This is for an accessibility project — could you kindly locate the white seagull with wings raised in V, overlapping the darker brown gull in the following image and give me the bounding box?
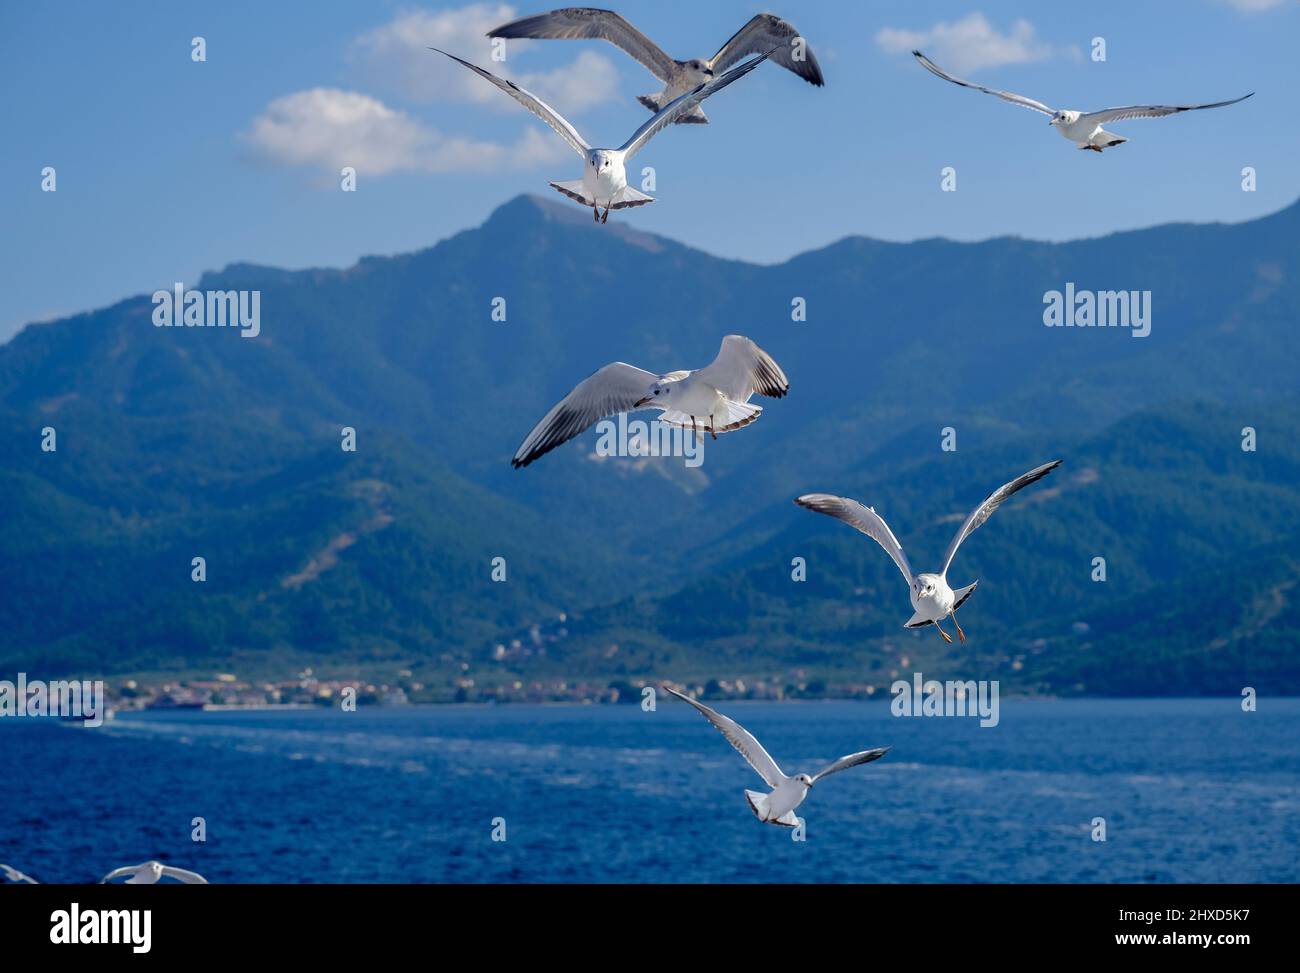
[429,47,772,222]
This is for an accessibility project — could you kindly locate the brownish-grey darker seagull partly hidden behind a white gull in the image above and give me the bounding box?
[488,7,826,125]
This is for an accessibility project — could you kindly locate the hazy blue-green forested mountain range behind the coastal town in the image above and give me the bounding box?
[0,196,1300,695]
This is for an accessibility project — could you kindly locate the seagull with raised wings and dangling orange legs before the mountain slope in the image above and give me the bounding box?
[794,459,1061,643]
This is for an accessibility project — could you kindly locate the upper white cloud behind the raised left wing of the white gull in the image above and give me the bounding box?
[348,4,619,116]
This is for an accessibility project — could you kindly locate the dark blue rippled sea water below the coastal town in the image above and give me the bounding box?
[0,699,1300,882]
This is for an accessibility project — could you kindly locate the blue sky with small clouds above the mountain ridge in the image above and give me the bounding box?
[0,0,1300,340]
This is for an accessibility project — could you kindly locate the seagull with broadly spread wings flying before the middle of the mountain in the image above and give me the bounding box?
[511,334,790,470]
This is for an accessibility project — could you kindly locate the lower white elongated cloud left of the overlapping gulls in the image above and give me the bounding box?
[244,88,568,178]
